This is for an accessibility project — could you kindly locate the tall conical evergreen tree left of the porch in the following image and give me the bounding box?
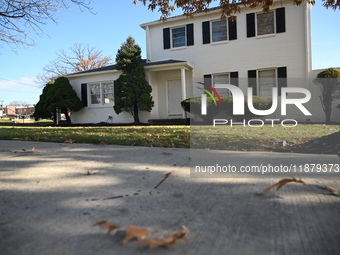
[113,37,154,125]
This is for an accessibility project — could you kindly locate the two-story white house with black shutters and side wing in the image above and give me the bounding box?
[66,1,340,123]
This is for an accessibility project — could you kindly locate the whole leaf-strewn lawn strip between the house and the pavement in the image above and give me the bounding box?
[0,119,340,151]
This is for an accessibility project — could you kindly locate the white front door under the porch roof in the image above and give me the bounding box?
[168,79,183,117]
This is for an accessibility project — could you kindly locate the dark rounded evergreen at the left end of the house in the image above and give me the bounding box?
[33,77,83,124]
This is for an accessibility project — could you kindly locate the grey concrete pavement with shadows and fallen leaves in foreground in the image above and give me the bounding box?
[0,141,340,255]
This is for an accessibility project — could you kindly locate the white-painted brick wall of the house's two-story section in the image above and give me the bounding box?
[142,2,319,121]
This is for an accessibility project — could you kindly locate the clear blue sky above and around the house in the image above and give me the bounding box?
[0,0,340,105]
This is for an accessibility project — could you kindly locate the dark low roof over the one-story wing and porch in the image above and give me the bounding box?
[65,59,191,78]
